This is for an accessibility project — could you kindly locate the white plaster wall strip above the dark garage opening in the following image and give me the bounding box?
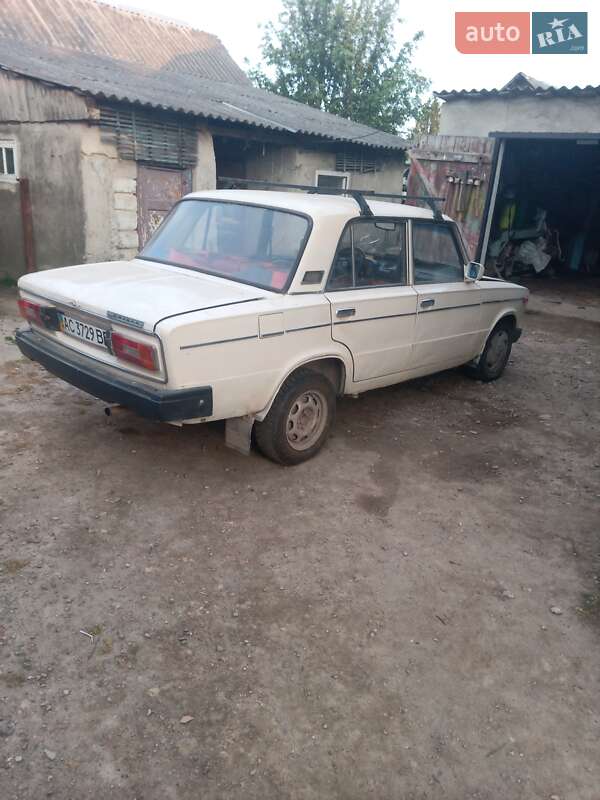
[440,97,600,136]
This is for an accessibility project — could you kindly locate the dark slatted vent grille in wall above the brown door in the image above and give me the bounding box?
[100,107,196,169]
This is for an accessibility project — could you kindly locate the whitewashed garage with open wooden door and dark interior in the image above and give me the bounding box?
[409,73,600,290]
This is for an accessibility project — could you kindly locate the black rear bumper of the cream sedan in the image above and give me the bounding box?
[16,330,213,422]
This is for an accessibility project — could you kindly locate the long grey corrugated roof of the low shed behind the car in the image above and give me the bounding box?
[0,34,408,150]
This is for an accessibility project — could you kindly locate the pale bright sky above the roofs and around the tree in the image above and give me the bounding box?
[110,0,600,91]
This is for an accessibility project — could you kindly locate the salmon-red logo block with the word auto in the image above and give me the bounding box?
[454,11,531,55]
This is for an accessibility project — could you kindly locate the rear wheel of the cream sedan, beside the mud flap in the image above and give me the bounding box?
[254,369,335,466]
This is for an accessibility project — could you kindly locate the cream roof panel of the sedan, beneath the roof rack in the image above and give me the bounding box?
[184,189,440,219]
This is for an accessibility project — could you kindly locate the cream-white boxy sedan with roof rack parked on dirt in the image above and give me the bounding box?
[17,189,528,465]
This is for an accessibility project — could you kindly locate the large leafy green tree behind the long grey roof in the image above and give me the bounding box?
[250,0,429,133]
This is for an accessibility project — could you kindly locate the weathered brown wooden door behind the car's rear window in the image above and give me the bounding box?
[137,164,192,249]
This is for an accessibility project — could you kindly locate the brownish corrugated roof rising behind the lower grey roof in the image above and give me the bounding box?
[0,0,250,84]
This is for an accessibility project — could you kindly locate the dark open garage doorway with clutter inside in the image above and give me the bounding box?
[485,137,600,280]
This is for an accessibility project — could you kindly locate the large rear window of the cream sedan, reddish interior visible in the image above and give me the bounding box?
[140,200,309,291]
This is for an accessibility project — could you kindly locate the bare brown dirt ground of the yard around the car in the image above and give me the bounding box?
[0,292,600,800]
